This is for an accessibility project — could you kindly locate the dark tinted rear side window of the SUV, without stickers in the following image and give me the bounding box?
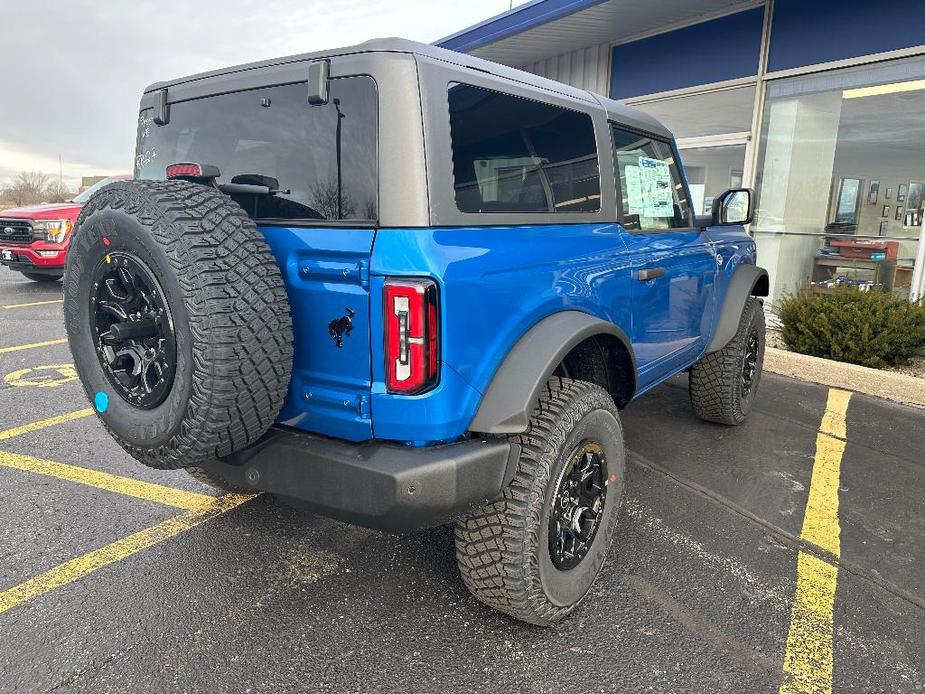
[449,84,601,213]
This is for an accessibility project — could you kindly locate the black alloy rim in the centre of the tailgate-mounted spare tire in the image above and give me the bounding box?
[90,251,177,409]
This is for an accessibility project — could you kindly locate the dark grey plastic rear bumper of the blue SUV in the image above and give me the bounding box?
[204,426,520,532]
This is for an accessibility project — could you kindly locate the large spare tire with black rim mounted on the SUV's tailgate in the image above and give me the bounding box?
[64,181,292,469]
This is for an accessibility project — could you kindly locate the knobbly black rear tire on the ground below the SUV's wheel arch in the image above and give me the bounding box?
[456,377,626,626]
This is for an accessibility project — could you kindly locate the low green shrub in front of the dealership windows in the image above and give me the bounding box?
[779,288,925,368]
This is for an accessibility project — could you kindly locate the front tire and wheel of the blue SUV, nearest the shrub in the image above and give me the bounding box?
[688,297,765,426]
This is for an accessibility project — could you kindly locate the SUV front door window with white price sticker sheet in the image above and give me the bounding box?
[613,126,691,231]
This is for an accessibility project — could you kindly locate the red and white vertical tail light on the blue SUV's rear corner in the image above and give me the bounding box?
[383,279,440,395]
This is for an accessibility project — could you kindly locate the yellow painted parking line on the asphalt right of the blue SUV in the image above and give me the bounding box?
[780,388,851,694]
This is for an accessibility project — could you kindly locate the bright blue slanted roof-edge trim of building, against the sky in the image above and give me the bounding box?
[435,0,607,53]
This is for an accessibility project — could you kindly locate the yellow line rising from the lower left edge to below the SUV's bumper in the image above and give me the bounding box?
[0,494,254,613]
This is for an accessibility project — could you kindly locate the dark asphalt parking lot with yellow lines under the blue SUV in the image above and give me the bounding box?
[0,268,925,693]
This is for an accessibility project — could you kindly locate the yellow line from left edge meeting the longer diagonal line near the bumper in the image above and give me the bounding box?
[0,451,215,511]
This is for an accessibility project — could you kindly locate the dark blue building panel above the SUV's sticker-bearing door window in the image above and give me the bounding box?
[610,7,764,99]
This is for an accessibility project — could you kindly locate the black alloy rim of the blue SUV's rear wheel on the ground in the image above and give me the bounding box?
[549,441,607,571]
